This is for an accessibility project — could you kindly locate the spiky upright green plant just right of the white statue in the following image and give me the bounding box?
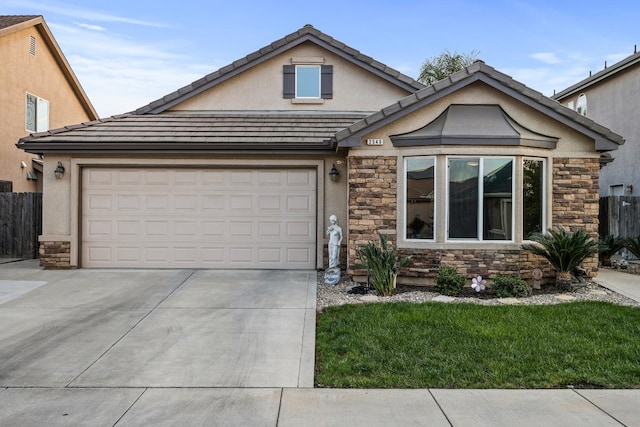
[356,233,411,296]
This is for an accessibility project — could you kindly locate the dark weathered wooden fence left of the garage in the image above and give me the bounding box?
[0,193,42,259]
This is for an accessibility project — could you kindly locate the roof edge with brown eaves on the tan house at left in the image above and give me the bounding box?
[0,15,98,119]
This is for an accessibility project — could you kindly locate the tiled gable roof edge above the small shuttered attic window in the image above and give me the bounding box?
[135,24,425,114]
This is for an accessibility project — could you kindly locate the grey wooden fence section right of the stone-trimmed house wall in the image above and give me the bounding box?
[599,196,640,237]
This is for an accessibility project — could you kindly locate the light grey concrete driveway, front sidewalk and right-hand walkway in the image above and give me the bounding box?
[0,261,640,427]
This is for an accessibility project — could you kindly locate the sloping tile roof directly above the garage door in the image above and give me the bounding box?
[18,112,370,153]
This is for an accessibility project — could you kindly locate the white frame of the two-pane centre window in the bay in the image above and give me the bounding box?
[445,155,517,245]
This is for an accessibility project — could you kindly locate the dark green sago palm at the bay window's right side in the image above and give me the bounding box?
[522,227,598,291]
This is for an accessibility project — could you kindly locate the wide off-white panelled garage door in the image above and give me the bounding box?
[80,168,316,269]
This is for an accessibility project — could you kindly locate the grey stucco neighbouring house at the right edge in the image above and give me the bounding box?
[553,52,640,197]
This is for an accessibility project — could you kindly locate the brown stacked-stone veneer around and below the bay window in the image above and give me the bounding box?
[348,157,599,280]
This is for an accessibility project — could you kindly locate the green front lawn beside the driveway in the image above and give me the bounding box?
[315,302,640,388]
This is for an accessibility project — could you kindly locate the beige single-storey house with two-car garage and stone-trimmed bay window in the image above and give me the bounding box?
[19,26,622,281]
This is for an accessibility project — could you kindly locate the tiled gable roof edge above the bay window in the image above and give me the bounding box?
[336,61,624,151]
